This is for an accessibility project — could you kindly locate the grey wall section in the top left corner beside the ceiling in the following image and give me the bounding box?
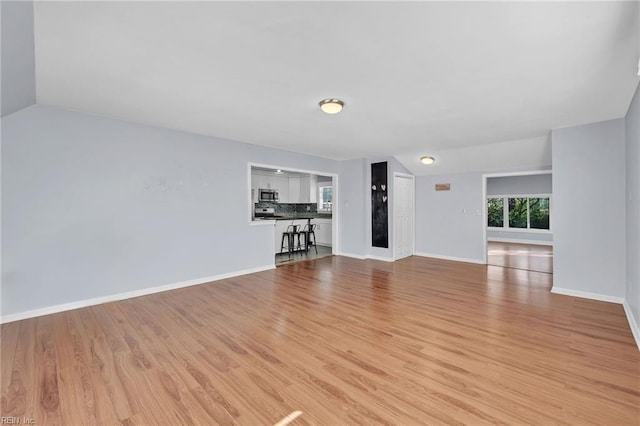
[0,1,36,117]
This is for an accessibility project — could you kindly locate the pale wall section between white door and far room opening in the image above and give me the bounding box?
[416,173,486,263]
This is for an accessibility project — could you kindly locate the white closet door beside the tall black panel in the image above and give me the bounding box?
[393,175,415,259]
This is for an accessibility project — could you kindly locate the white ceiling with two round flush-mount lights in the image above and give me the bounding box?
[34,1,639,174]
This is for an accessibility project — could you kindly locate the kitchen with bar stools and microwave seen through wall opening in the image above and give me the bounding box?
[251,166,333,265]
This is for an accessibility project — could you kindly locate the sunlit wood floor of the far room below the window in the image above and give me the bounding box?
[487,241,553,274]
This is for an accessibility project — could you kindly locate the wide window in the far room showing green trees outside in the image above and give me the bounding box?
[487,195,551,231]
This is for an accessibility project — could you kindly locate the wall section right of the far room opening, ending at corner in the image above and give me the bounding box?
[552,119,626,298]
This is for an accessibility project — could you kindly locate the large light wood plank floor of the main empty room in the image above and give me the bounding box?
[1,256,640,425]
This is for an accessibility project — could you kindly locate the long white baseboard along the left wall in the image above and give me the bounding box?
[0,265,275,324]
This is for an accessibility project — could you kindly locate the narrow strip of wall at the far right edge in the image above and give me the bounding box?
[624,83,640,338]
